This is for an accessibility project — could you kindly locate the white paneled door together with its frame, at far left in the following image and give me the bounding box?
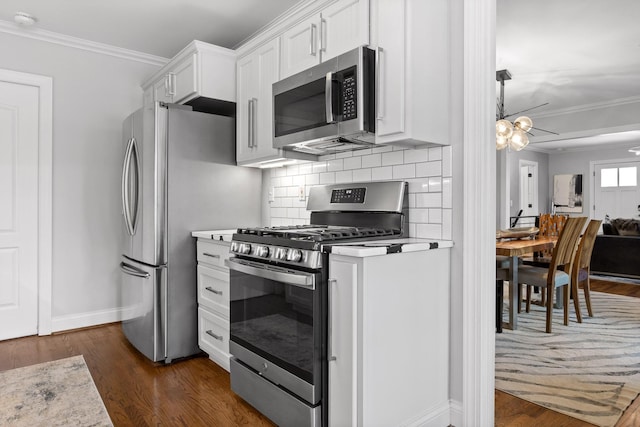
[0,69,53,339]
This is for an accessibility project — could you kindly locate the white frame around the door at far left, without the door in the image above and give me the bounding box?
[0,69,53,335]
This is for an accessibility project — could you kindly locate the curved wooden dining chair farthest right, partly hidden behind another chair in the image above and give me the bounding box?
[571,219,602,323]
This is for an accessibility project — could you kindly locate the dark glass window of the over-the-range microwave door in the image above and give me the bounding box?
[273,79,327,137]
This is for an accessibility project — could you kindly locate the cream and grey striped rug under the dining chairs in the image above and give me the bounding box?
[496,291,640,426]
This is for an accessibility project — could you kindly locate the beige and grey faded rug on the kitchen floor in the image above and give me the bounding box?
[0,356,113,427]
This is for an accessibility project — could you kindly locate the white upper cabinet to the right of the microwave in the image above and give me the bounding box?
[371,0,451,145]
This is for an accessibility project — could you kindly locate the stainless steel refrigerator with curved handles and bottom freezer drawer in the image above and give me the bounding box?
[120,103,262,363]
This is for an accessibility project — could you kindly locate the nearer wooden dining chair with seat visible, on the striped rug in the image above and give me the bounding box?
[518,217,587,333]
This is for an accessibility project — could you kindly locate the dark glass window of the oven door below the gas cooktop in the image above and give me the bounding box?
[231,271,322,384]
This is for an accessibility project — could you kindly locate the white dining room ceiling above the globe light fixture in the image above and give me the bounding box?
[496,0,640,149]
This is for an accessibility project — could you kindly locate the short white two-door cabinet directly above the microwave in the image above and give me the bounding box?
[281,0,369,78]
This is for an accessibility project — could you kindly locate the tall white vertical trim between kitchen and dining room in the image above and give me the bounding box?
[461,0,496,426]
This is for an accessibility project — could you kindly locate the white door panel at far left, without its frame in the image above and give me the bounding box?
[0,81,39,340]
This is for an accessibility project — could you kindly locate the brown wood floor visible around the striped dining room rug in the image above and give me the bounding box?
[495,280,640,427]
